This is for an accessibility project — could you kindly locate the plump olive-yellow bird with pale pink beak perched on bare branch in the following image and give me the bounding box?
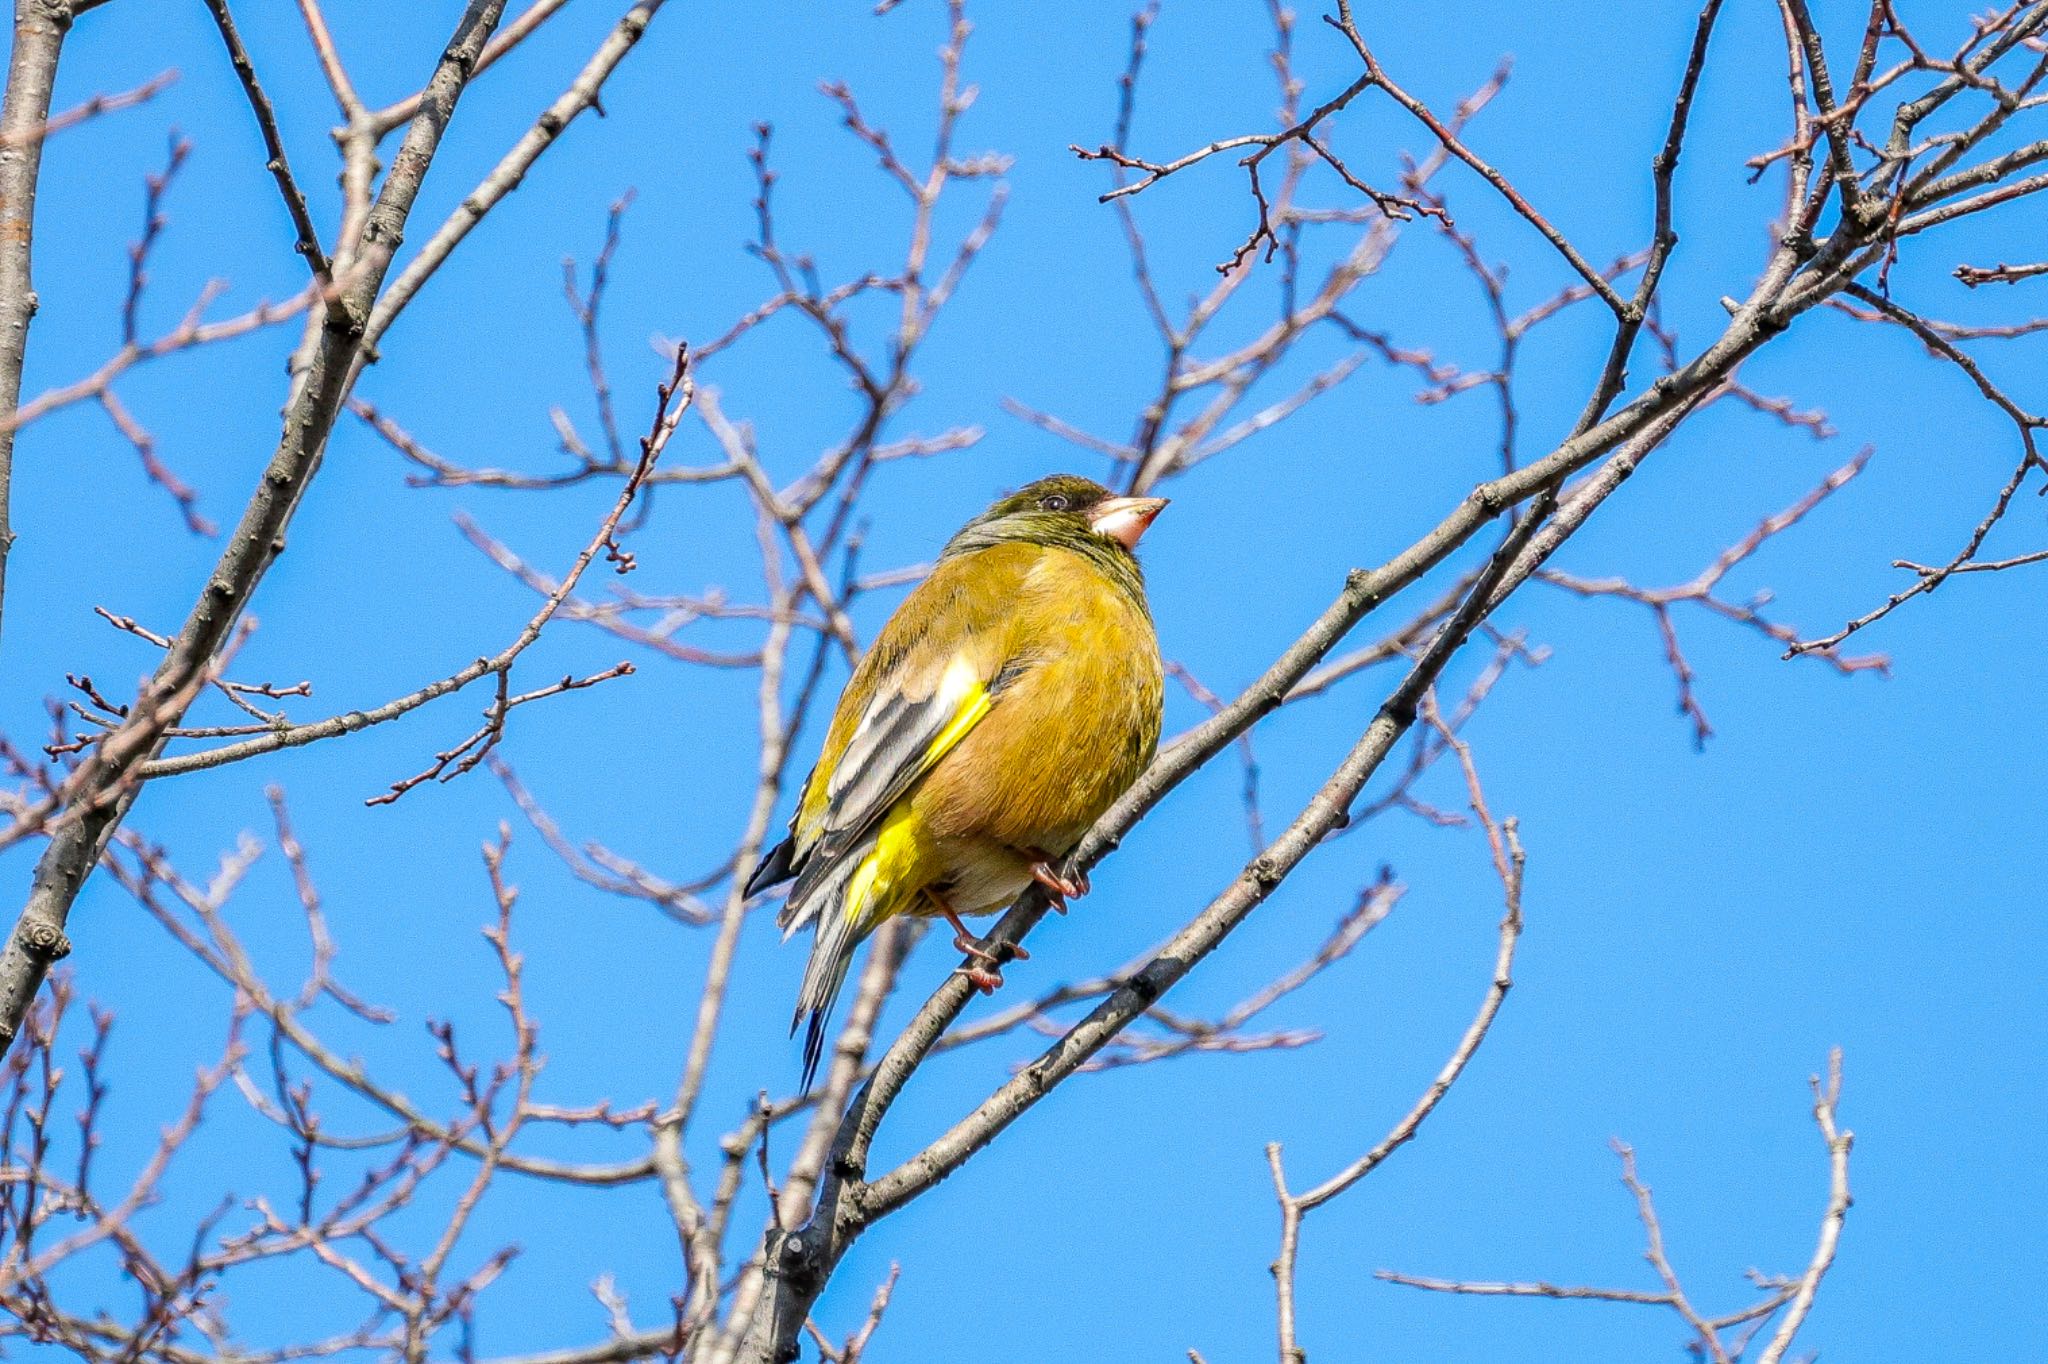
[745,475,1165,1090]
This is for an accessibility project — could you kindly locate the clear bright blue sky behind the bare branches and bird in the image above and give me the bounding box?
[0,0,2048,1364]
